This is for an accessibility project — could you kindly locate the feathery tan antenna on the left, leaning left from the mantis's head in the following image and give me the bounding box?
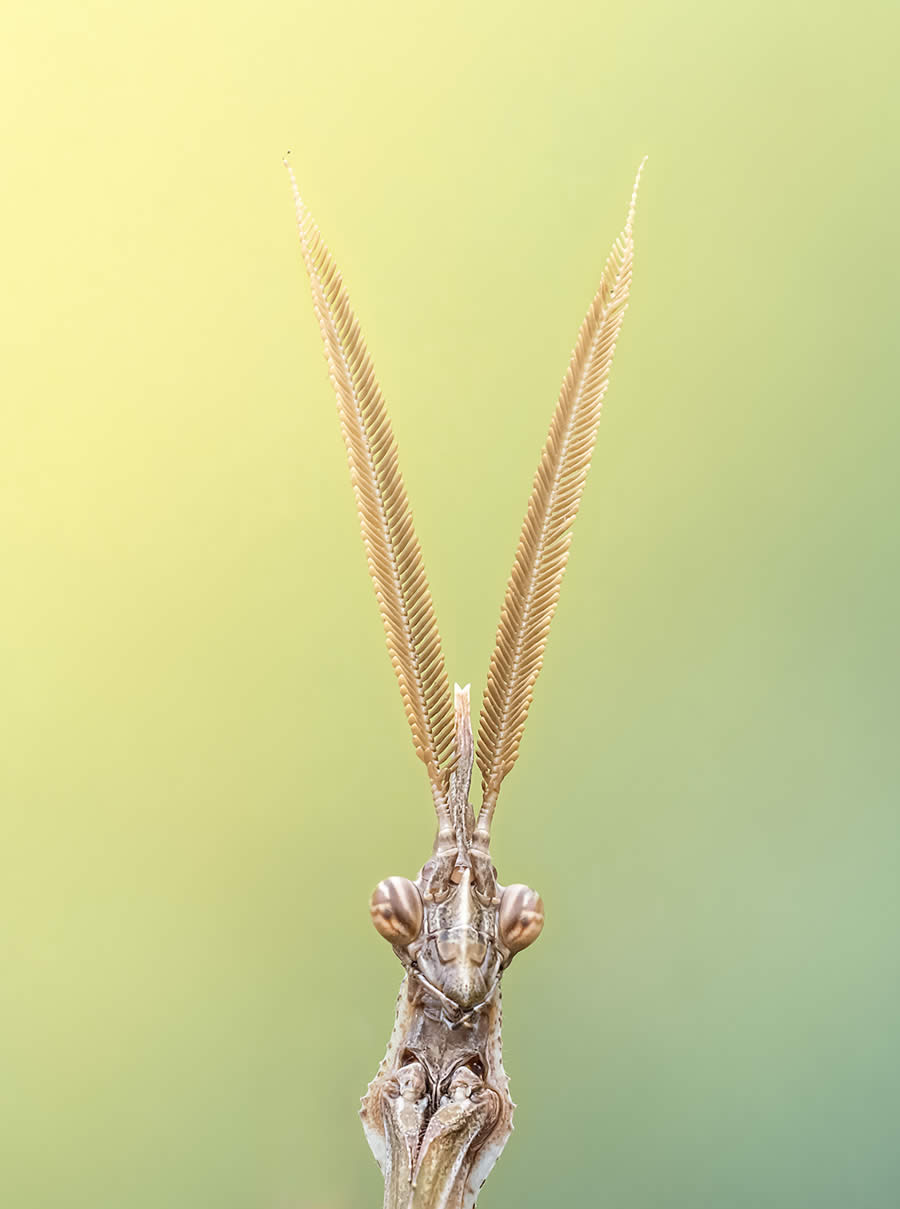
[284,160,455,828]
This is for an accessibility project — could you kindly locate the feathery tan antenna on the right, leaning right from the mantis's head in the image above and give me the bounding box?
[474,158,646,849]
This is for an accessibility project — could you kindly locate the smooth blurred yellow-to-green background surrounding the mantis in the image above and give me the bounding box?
[0,0,900,1209]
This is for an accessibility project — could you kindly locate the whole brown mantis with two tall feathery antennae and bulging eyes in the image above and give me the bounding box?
[285,160,644,1209]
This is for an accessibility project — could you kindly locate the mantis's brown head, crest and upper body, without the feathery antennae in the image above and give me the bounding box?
[362,686,543,1209]
